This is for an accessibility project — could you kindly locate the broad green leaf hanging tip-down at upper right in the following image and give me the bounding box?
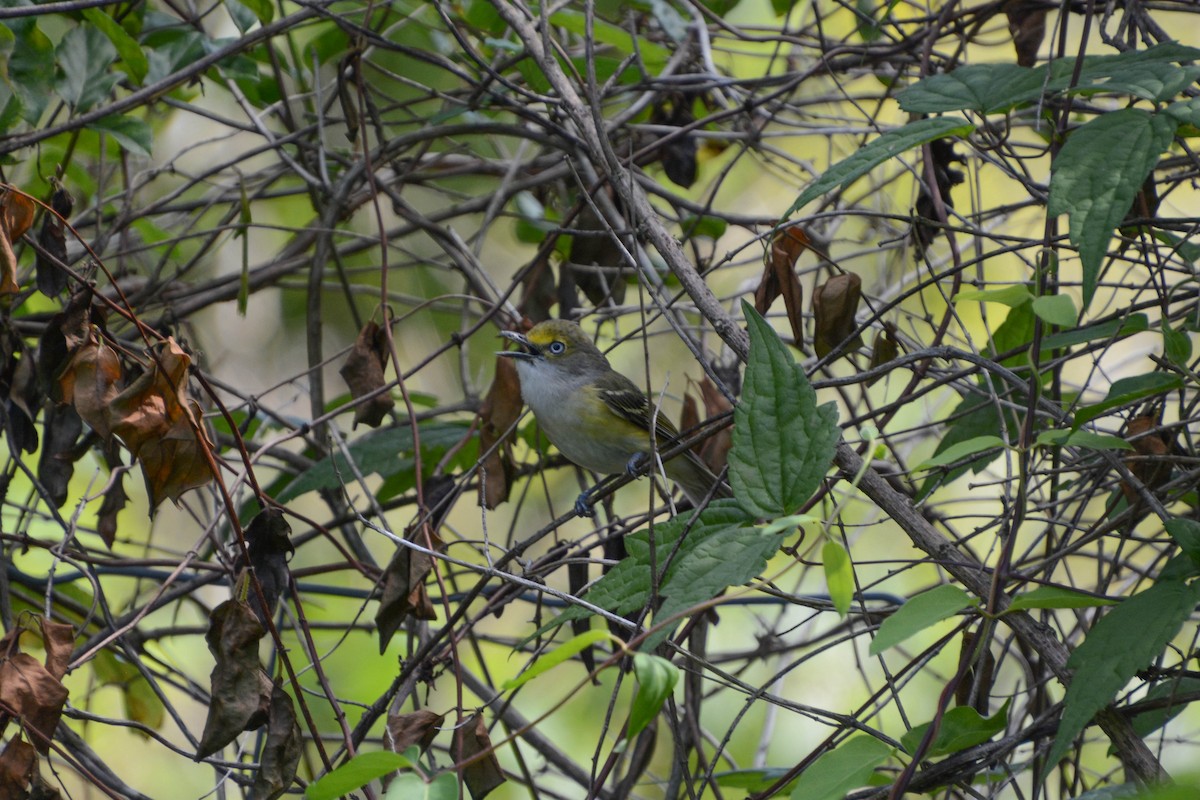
[1046,108,1175,311]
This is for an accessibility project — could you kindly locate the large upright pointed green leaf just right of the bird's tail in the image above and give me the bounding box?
[728,302,841,519]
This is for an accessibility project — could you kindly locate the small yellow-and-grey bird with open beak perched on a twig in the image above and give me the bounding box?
[499,319,730,517]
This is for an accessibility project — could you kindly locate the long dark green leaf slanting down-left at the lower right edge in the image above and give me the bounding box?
[1043,581,1200,778]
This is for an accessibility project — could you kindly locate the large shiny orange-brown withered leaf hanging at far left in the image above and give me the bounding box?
[108,338,212,509]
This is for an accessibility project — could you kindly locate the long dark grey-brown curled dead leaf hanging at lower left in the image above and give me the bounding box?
[196,600,274,760]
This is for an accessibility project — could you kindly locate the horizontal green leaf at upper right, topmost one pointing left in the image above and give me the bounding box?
[896,64,1046,114]
